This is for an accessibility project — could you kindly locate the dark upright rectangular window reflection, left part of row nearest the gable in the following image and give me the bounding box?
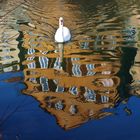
[40,77,49,91]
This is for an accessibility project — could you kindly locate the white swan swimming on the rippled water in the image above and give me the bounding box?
[55,17,71,43]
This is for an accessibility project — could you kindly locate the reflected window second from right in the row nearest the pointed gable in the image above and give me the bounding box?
[84,87,96,101]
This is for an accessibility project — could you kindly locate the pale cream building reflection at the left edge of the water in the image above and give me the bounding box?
[0,26,20,72]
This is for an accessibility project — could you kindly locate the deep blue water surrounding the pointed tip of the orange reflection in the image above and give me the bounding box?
[0,72,140,140]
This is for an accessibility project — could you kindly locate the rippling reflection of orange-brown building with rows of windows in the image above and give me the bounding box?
[23,31,120,129]
